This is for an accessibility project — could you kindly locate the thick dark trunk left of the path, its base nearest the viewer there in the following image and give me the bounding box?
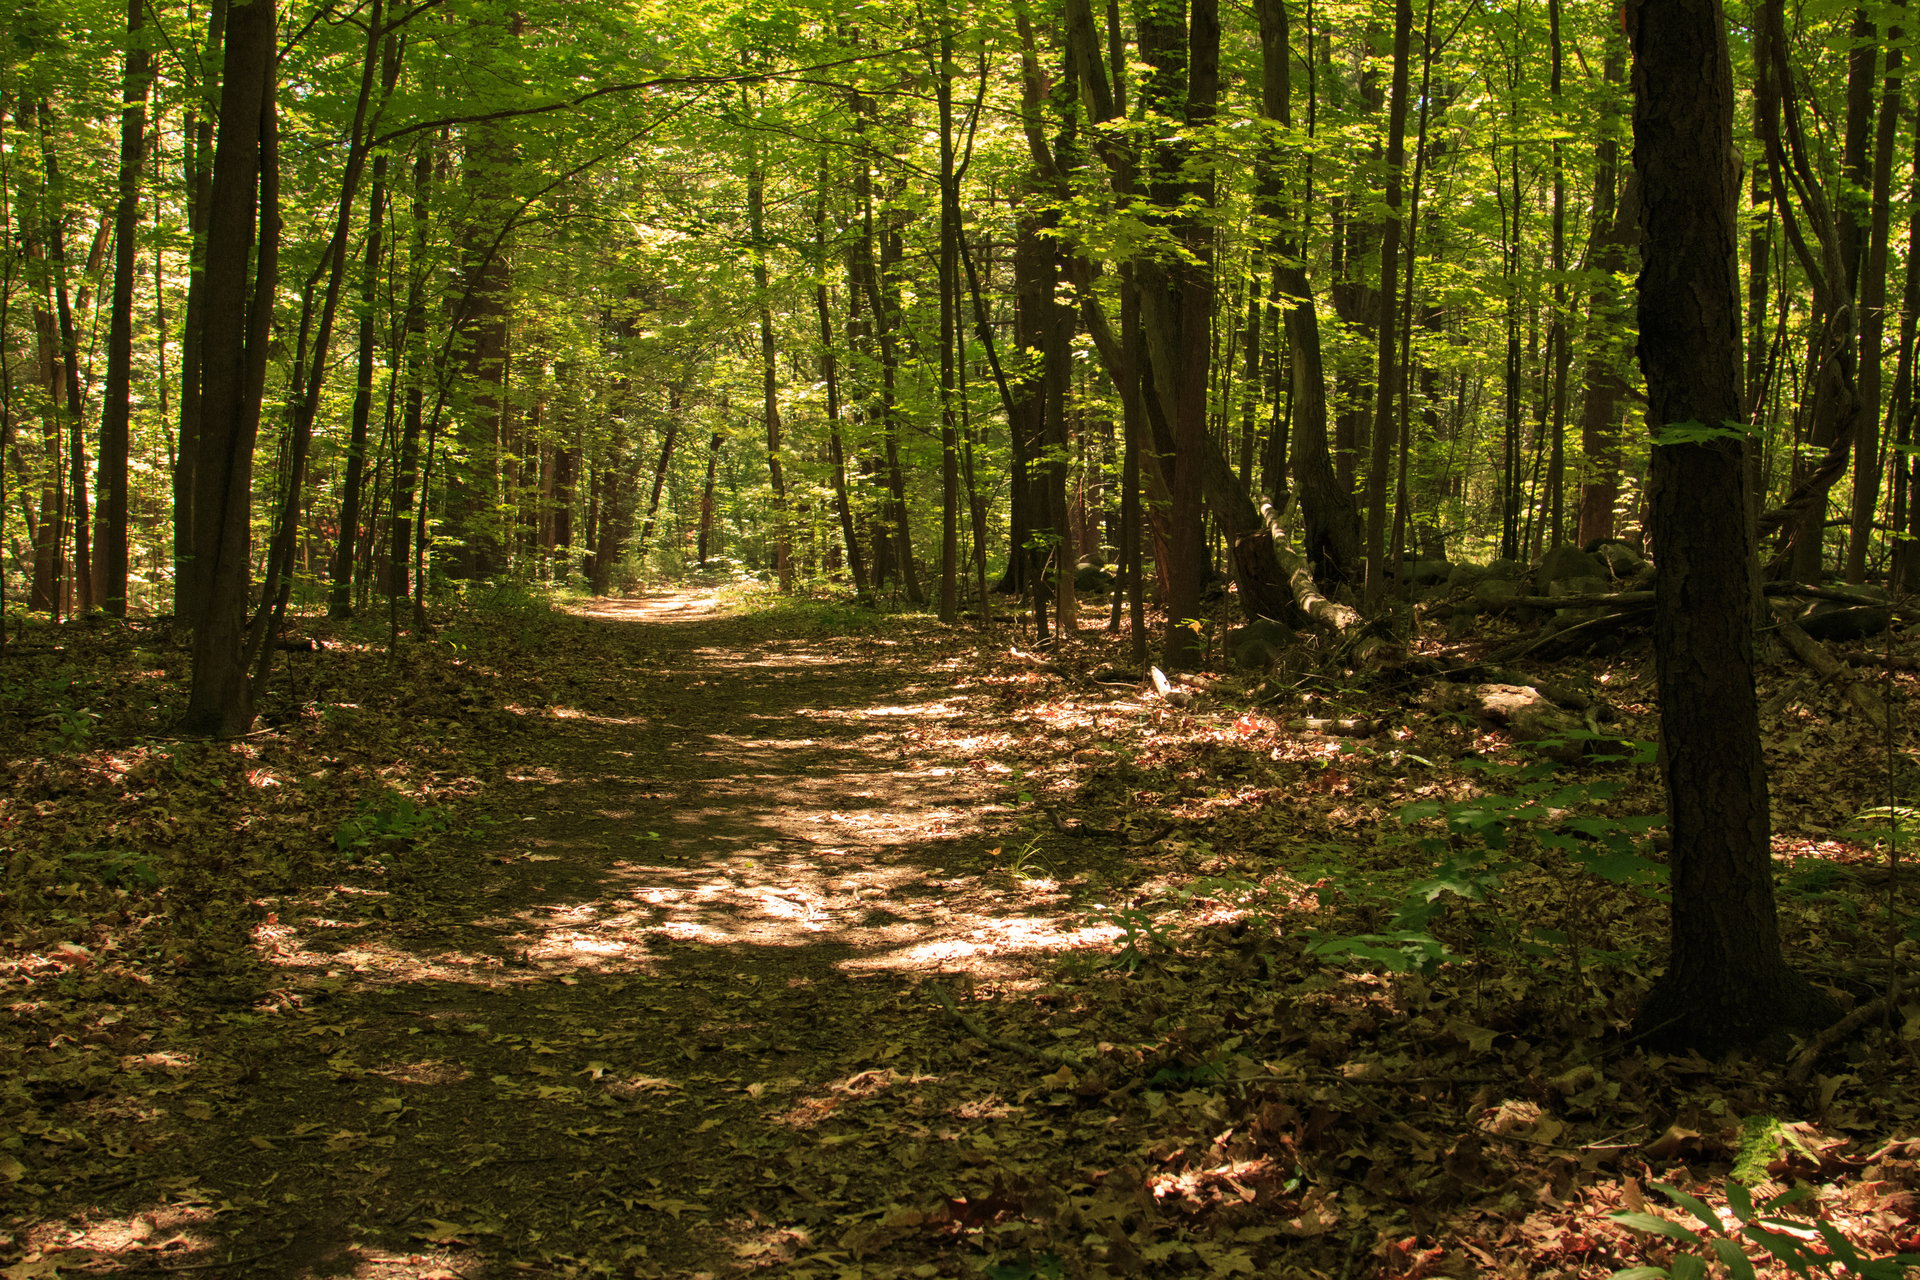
[182,0,280,735]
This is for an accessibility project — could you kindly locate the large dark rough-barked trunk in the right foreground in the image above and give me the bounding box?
[1626,0,1832,1052]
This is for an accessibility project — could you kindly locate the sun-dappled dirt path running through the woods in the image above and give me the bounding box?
[120,595,1105,1278]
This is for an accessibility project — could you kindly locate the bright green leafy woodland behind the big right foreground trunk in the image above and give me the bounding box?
[0,0,1920,714]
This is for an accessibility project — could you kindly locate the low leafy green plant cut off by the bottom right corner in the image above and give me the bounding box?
[1611,1180,1920,1280]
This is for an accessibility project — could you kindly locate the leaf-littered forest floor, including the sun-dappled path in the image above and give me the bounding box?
[0,591,1920,1280]
